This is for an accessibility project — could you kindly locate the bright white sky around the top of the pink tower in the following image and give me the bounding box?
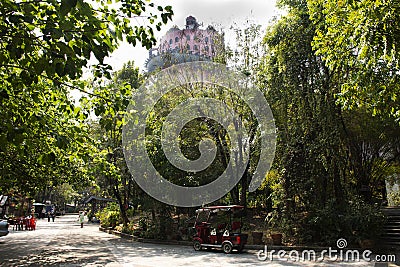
[105,0,282,70]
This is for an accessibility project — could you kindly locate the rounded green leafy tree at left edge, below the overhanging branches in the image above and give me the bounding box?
[0,79,90,196]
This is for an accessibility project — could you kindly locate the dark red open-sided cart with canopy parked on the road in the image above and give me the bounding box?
[193,205,248,254]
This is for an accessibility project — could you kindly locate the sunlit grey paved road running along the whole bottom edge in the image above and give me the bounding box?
[0,215,396,267]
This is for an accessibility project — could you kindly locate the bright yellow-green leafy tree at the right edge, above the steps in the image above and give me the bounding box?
[307,0,400,197]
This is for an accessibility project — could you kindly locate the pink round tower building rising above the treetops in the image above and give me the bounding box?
[146,16,224,72]
